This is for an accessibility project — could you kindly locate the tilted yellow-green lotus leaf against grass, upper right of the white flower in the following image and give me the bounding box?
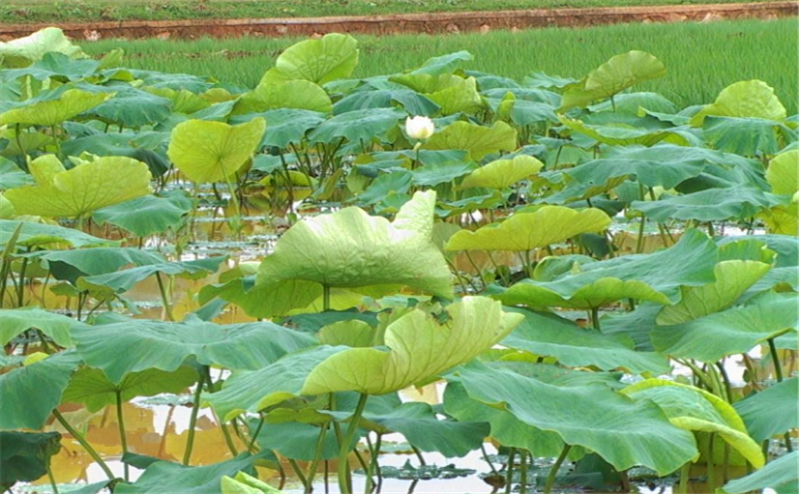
[561,50,667,110]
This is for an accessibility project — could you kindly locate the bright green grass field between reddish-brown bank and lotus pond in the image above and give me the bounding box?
[82,19,798,114]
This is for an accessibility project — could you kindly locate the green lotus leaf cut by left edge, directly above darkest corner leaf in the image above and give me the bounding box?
[0,350,80,430]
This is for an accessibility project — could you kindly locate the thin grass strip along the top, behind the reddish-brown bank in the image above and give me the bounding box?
[0,0,780,23]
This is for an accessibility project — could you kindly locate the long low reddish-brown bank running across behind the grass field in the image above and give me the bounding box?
[0,0,798,39]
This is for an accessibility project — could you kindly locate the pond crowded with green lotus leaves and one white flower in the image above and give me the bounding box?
[0,28,798,494]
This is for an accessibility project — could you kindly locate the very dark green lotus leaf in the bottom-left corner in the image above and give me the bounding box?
[0,431,61,490]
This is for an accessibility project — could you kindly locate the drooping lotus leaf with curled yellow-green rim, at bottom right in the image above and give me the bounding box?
[620,379,765,468]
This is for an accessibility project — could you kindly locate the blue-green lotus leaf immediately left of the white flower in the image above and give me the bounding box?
[308,108,406,144]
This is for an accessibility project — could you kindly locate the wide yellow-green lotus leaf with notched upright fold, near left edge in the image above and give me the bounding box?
[5,155,151,218]
